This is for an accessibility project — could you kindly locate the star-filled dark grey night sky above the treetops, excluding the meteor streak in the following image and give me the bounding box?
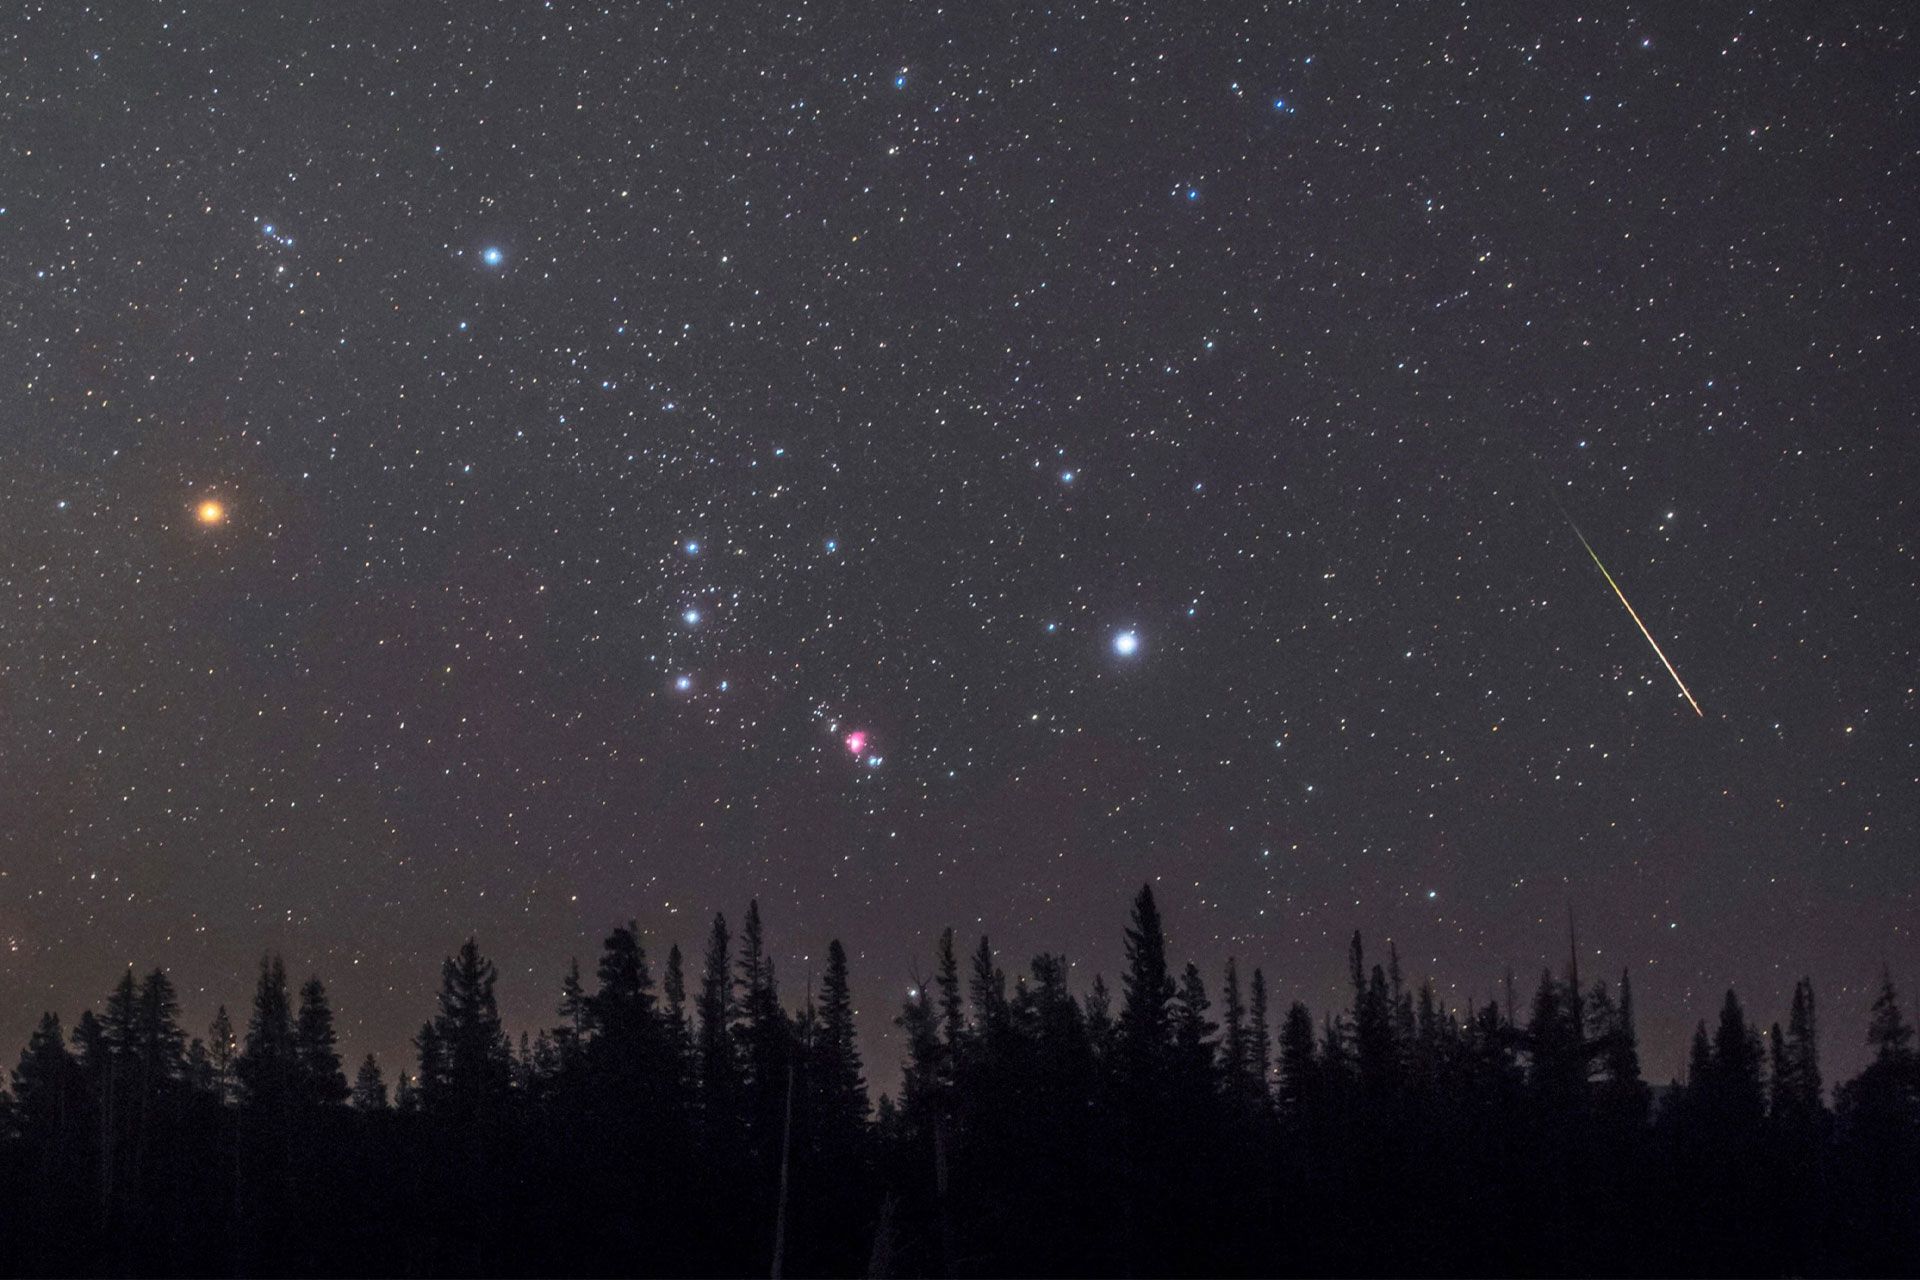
[0,0,1920,1090]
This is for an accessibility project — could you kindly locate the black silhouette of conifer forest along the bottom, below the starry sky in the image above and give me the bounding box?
[0,889,1920,1276]
